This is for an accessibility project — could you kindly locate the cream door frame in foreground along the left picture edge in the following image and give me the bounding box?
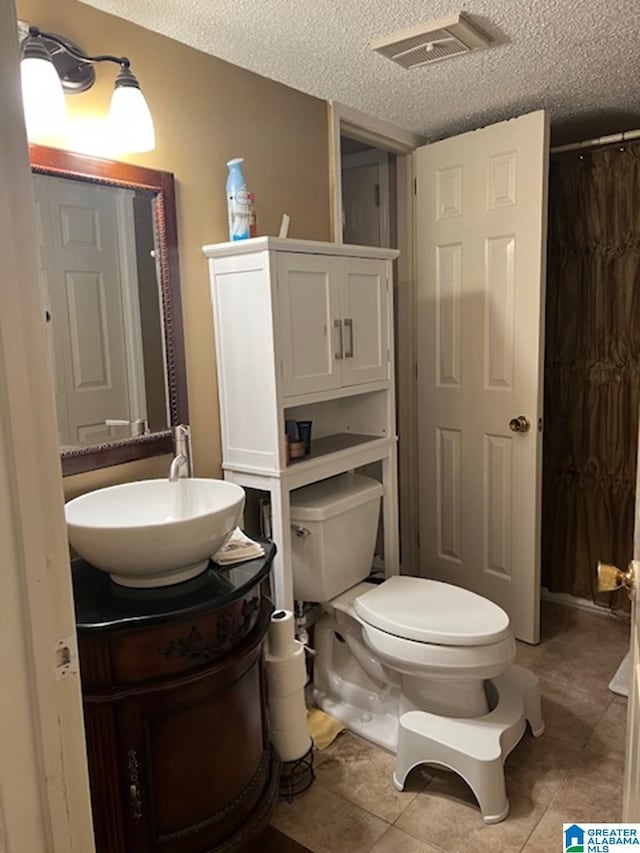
[0,3,94,853]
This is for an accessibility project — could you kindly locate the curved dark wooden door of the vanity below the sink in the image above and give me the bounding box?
[118,650,270,853]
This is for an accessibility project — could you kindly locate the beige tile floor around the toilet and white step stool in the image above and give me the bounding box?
[272,602,629,853]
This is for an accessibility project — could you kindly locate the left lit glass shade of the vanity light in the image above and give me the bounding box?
[20,57,67,142]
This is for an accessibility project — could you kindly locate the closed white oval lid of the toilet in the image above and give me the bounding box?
[354,575,511,646]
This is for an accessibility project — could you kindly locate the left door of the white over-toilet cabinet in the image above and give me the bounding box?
[277,252,344,397]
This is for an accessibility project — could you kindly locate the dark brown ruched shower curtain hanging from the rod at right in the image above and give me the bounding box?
[542,143,640,598]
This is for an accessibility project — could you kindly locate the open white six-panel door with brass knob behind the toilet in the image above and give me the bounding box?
[416,112,548,643]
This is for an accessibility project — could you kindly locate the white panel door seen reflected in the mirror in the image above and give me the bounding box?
[34,175,137,445]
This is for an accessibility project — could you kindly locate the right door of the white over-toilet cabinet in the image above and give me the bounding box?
[339,258,389,385]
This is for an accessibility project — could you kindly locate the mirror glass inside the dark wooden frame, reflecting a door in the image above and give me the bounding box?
[33,174,170,449]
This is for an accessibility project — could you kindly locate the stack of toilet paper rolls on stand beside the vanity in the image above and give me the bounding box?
[265,610,311,761]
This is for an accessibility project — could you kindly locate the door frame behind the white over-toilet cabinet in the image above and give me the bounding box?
[329,101,425,575]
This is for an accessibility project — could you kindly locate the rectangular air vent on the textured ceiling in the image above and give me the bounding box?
[371,12,491,69]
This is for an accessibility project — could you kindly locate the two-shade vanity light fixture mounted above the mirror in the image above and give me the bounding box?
[21,27,155,153]
